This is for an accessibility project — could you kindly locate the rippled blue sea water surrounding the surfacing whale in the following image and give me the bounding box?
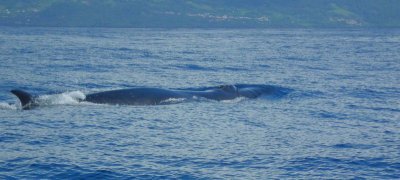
[0,27,400,179]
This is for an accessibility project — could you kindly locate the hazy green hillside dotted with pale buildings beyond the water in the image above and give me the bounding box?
[0,0,400,28]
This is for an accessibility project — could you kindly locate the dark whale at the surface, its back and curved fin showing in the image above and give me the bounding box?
[11,85,276,110]
